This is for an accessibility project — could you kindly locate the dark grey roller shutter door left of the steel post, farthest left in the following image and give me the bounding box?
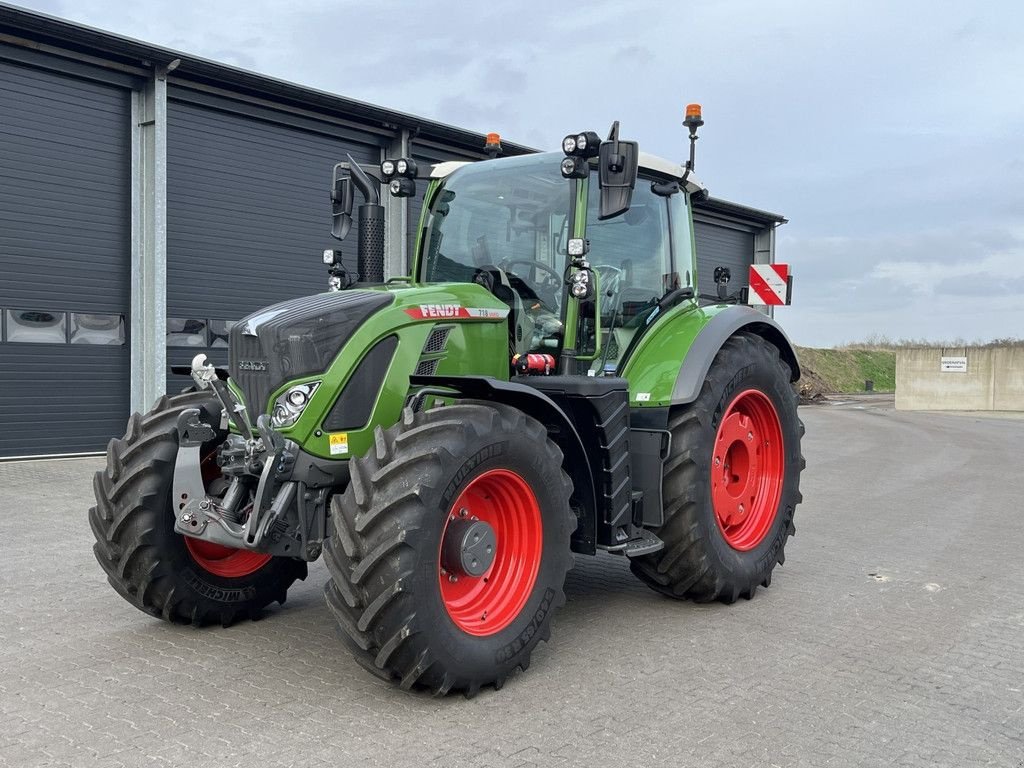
[0,60,130,457]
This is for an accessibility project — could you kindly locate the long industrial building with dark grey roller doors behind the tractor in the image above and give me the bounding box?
[0,4,784,458]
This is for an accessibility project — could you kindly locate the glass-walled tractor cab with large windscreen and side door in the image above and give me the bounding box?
[413,153,701,375]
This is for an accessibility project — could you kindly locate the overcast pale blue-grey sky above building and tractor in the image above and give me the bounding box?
[22,0,1024,346]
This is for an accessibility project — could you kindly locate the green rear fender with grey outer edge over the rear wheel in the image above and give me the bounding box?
[622,304,800,408]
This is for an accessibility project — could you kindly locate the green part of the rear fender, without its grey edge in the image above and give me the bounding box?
[618,299,728,408]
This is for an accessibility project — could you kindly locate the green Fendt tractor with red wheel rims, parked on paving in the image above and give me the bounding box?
[89,108,804,695]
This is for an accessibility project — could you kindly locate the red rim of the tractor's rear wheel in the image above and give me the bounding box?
[711,389,785,552]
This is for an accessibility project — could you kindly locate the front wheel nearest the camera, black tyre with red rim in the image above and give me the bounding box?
[324,402,575,695]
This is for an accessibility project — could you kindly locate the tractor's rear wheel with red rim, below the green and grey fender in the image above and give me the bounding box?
[631,334,805,603]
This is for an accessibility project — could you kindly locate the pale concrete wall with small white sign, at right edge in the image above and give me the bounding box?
[896,346,1024,411]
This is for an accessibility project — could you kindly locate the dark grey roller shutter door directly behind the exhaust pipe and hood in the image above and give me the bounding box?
[167,98,380,392]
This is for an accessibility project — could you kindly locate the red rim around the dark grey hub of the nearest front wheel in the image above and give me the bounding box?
[438,469,544,637]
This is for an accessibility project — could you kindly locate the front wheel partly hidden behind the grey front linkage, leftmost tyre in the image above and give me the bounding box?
[89,392,306,627]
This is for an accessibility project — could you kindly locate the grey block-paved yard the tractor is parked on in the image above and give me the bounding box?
[0,399,1024,768]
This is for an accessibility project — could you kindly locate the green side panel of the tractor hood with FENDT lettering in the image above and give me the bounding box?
[260,283,509,459]
